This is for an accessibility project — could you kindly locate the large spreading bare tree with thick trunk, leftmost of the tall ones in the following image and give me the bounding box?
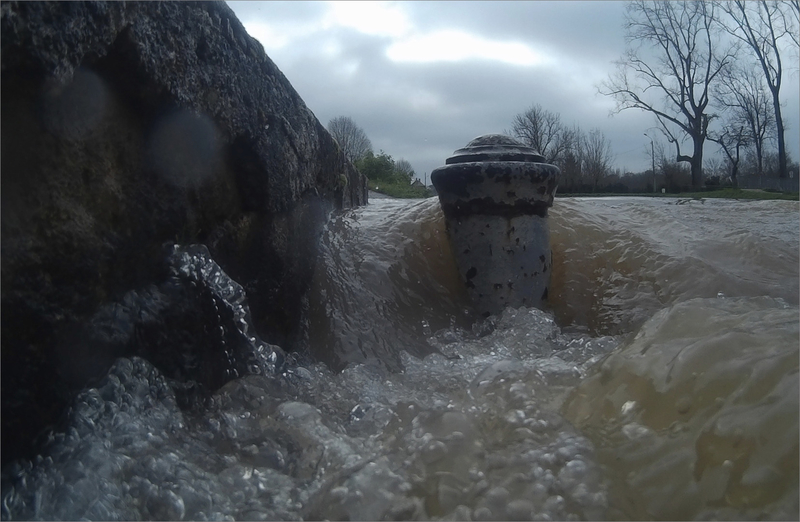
[599,0,732,187]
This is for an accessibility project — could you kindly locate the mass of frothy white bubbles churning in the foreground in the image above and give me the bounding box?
[9,256,620,520]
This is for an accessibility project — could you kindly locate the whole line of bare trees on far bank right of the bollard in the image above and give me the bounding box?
[512,0,800,192]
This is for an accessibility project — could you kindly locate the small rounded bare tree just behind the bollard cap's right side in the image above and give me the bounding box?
[512,103,571,163]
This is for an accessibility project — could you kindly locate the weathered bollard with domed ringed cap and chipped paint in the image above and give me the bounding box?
[431,134,559,317]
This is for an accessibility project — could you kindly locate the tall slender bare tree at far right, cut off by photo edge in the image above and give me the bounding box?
[720,0,797,178]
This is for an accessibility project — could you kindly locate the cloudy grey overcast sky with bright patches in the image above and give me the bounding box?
[228,0,800,183]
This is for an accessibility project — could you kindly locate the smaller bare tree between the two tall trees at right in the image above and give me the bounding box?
[709,61,775,175]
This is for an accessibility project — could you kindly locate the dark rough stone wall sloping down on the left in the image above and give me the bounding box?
[0,2,367,462]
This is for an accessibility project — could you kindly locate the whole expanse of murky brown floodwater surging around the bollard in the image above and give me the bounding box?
[2,198,800,520]
